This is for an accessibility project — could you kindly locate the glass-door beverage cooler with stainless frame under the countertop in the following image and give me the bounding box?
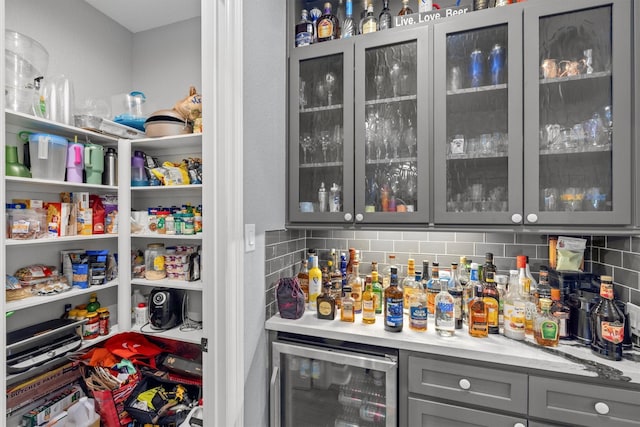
[270,333,398,427]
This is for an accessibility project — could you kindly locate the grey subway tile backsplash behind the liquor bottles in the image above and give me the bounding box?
[265,230,640,318]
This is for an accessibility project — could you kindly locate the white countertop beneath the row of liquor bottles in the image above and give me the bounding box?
[265,311,640,385]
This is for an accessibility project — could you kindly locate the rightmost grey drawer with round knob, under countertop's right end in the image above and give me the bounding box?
[529,376,640,427]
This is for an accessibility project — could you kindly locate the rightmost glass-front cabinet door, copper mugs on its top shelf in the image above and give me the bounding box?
[524,0,632,225]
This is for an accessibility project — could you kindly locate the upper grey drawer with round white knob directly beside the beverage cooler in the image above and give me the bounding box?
[408,356,527,414]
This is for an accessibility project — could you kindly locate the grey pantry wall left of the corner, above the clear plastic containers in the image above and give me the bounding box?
[5,0,133,108]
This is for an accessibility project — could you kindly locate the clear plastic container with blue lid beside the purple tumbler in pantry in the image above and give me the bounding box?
[29,133,67,181]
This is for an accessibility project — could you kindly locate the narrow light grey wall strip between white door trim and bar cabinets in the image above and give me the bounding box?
[243,0,287,427]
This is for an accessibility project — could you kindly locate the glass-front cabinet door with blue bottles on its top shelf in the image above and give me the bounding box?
[433,6,523,224]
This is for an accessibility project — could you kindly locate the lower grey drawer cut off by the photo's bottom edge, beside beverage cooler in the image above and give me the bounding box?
[409,397,527,427]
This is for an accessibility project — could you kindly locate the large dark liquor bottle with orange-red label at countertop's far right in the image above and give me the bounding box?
[590,276,625,360]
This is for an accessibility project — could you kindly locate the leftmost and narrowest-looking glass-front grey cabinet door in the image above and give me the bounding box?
[288,40,353,223]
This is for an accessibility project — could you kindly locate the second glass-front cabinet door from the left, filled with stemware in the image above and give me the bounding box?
[354,27,431,224]
